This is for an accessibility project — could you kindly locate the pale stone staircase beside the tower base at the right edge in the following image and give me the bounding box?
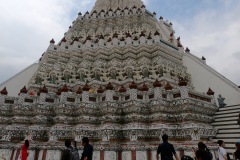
[212,104,240,158]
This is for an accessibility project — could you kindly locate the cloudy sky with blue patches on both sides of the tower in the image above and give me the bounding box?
[0,0,240,85]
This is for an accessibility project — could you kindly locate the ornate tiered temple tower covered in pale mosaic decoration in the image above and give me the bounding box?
[0,0,239,160]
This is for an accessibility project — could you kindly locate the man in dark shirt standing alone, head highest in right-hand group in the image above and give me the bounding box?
[156,134,179,160]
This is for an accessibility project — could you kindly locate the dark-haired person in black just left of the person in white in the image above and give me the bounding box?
[195,142,213,160]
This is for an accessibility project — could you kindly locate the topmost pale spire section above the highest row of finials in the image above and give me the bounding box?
[92,0,143,12]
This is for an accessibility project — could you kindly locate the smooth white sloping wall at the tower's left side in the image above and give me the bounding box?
[0,63,39,97]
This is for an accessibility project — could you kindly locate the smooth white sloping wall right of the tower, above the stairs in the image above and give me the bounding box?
[183,53,240,105]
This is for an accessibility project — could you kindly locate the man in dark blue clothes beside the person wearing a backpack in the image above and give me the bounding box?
[81,137,93,160]
